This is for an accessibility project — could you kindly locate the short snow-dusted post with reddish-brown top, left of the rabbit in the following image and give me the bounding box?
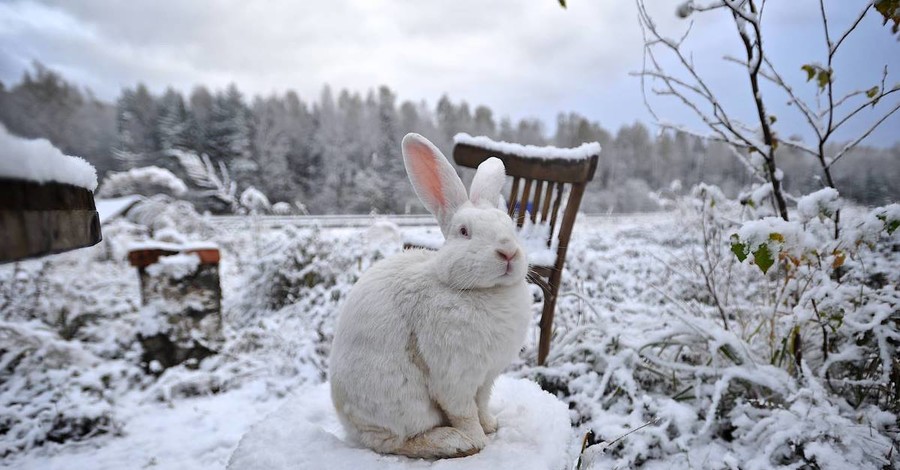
[128,242,222,373]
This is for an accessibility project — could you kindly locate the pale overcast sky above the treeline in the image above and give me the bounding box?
[0,0,900,145]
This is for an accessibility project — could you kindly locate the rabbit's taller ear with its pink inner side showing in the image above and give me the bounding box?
[402,134,468,236]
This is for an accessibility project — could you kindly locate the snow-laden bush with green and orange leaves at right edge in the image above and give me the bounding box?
[732,199,900,413]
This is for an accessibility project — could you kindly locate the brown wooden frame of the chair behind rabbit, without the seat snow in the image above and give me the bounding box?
[453,138,600,365]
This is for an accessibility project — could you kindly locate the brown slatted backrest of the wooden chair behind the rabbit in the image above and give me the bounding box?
[453,142,600,269]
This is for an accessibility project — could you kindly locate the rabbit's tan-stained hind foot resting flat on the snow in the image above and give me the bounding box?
[357,426,479,459]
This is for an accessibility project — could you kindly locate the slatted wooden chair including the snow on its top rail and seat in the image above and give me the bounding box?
[453,134,600,365]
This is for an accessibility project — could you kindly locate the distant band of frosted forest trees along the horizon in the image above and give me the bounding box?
[0,64,900,214]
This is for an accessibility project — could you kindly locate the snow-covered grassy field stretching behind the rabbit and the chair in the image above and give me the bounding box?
[0,201,900,469]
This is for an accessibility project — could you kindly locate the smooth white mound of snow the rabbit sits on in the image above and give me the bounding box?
[228,377,572,470]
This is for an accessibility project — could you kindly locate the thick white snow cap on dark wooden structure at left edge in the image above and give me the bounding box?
[0,124,97,191]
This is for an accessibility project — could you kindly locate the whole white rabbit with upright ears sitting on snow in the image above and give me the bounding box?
[330,134,531,458]
